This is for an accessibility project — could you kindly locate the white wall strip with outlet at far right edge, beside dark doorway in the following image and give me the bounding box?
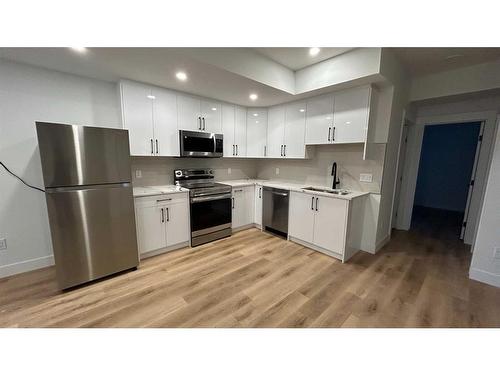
[469,117,500,287]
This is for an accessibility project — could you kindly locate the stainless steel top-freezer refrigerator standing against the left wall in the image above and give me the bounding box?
[36,122,139,289]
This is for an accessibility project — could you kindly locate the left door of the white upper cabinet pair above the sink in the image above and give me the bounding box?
[305,95,334,145]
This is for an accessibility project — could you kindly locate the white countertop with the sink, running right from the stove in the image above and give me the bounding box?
[219,179,370,200]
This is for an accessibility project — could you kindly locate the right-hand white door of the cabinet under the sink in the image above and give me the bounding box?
[313,196,348,254]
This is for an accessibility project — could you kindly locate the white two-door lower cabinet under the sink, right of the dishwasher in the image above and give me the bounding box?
[289,191,349,260]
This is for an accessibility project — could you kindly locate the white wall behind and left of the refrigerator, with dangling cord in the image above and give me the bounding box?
[0,60,121,277]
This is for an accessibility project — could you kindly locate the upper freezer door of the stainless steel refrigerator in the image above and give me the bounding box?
[36,122,131,187]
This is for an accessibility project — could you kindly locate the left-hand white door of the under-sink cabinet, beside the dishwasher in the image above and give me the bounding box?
[288,191,315,243]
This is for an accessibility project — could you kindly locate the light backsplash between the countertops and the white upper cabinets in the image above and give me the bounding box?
[132,144,385,193]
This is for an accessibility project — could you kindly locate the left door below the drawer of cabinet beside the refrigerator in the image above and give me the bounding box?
[136,205,167,254]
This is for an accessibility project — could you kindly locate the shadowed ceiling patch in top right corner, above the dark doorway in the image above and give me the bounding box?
[392,48,500,76]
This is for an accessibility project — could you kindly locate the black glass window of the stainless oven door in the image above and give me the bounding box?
[191,198,232,232]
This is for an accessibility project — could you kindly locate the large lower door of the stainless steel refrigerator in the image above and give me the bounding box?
[46,183,139,289]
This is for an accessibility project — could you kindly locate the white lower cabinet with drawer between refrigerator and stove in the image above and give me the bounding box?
[135,193,189,257]
